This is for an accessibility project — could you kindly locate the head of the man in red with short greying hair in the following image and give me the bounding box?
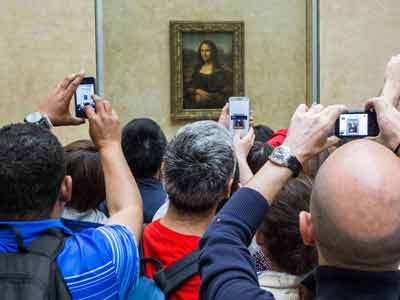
[163,121,236,215]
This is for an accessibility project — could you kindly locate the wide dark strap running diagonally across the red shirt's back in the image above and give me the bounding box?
[153,249,201,296]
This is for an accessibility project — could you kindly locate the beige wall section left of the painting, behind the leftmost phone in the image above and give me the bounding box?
[0,0,96,142]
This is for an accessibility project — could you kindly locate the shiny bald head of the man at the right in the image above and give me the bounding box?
[311,140,400,270]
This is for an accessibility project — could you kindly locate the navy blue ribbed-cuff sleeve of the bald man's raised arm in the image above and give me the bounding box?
[200,188,274,300]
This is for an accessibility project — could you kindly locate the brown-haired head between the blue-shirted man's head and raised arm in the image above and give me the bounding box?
[64,140,106,212]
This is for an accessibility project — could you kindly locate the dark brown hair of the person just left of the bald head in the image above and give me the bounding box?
[260,175,318,275]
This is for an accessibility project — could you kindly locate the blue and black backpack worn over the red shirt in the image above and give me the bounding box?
[128,238,200,300]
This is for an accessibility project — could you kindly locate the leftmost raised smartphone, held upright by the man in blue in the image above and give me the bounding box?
[75,77,96,118]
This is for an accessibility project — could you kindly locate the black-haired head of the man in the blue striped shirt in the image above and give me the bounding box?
[0,124,71,220]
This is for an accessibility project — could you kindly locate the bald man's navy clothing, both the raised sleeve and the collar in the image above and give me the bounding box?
[200,188,400,300]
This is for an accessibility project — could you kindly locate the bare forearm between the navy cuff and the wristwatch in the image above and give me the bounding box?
[246,161,292,204]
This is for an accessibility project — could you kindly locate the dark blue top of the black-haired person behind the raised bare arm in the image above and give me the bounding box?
[99,178,167,224]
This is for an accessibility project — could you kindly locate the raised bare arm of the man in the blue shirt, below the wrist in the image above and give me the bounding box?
[100,145,143,240]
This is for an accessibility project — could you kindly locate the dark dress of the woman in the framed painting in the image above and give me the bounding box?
[183,66,233,109]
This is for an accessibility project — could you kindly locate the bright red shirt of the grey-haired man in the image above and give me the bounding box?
[143,220,200,300]
